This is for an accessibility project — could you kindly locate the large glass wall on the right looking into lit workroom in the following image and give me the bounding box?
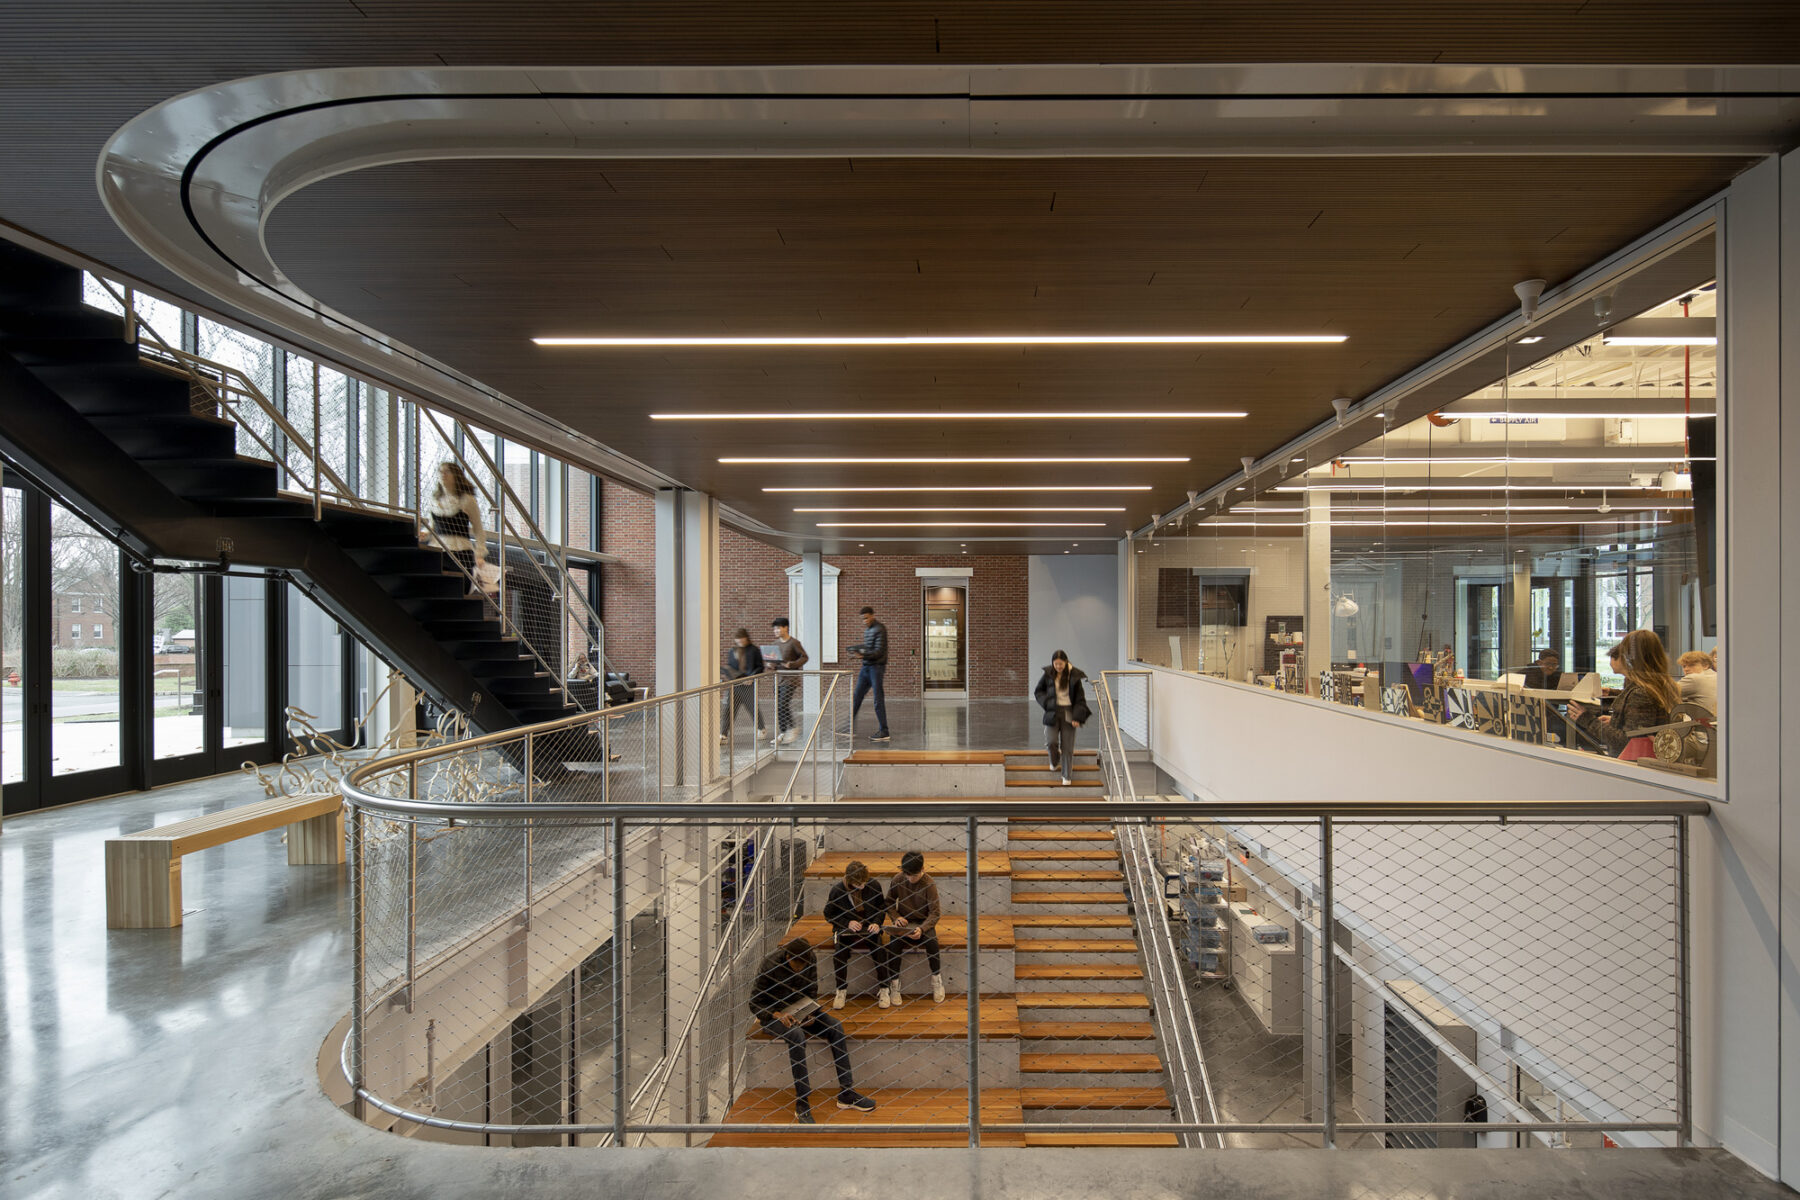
[1132,248,1723,775]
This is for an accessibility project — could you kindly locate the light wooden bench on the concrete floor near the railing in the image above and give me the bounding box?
[106,792,344,928]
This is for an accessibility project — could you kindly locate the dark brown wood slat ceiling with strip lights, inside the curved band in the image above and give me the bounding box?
[266,158,1746,549]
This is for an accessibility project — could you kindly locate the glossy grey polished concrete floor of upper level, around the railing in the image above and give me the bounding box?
[0,766,1795,1200]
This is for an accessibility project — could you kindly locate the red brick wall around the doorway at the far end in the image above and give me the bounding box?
[712,529,1037,700]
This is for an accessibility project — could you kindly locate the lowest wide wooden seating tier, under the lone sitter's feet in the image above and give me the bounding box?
[707,1087,1024,1148]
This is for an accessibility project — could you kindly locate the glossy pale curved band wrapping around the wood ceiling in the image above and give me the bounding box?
[97,65,1800,542]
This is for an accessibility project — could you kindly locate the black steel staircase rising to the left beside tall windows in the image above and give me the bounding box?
[0,243,592,737]
